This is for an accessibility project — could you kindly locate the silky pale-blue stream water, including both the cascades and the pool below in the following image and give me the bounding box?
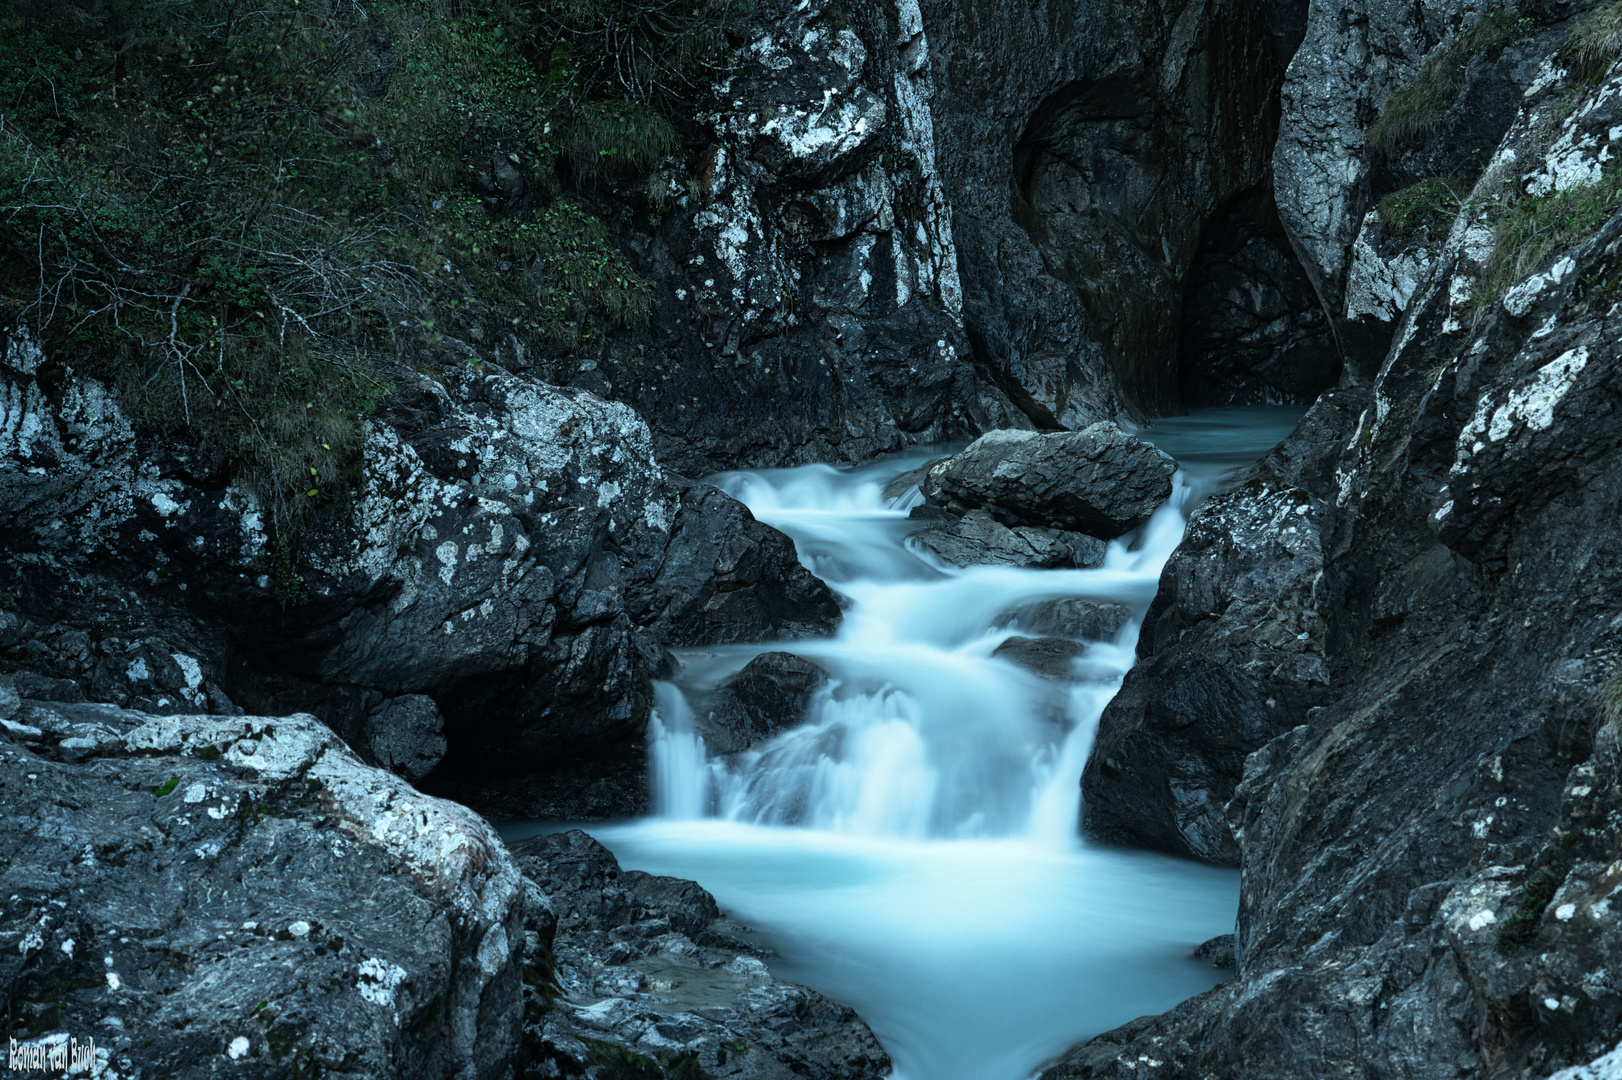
[506,409,1299,1080]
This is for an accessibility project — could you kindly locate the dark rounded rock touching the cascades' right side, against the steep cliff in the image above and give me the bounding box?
[1082,392,1367,864]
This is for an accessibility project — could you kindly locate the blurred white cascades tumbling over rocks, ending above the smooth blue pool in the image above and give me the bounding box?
[650,444,1192,842]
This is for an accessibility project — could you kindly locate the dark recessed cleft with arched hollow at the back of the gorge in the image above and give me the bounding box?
[1011,0,1341,418]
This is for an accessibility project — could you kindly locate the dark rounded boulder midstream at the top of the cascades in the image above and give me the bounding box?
[923,422,1178,540]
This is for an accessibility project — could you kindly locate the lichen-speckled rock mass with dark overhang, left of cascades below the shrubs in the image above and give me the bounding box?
[0,332,839,814]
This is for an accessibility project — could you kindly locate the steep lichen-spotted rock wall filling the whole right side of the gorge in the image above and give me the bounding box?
[1048,8,1622,1077]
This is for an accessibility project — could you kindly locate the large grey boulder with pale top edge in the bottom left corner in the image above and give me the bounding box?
[0,702,524,1080]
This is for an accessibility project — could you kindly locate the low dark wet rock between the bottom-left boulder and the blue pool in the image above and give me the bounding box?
[513,830,890,1080]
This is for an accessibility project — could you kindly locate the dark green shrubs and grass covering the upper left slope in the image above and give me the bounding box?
[0,0,741,530]
